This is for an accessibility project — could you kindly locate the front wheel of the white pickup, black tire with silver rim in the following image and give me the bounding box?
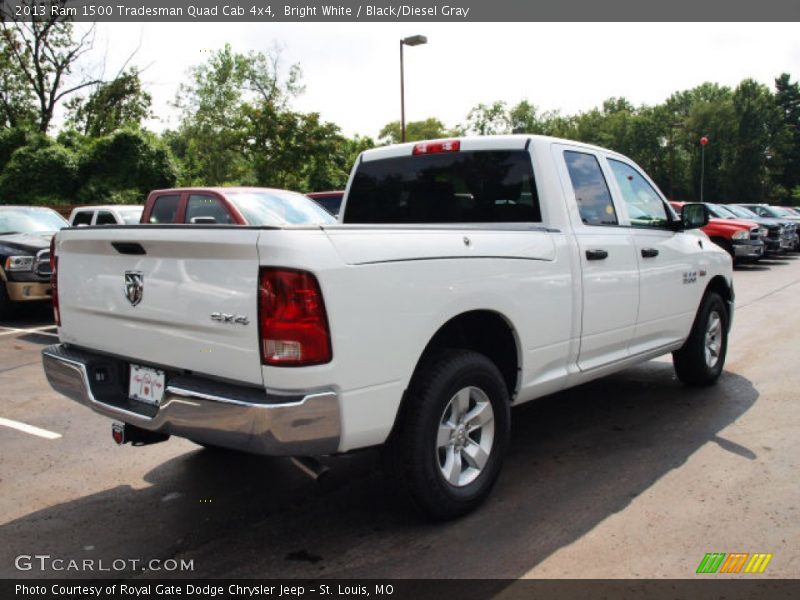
[672,292,729,386]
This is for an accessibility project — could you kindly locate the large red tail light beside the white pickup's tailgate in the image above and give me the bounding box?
[258,268,332,367]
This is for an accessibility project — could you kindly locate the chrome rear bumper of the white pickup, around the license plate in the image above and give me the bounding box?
[42,344,341,456]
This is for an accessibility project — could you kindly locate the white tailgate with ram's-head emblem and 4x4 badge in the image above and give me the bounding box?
[57,226,263,385]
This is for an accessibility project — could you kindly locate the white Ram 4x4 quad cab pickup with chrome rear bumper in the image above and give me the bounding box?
[43,136,734,518]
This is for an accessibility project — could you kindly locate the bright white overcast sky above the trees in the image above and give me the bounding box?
[72,23,800,137]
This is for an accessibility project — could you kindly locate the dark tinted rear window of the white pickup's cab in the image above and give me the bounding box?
[343,150,542,224]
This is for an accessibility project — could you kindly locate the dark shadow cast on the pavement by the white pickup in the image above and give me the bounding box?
[0,362,759,578]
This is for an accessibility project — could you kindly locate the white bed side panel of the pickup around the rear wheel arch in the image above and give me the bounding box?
[260,226,576,450]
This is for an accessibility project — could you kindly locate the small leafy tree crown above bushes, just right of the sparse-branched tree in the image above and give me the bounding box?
[66,69,152,137]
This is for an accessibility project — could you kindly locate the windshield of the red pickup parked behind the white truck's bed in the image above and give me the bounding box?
[227,190,336,227]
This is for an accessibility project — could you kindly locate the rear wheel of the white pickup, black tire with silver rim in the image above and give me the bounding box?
[384,350,510,520]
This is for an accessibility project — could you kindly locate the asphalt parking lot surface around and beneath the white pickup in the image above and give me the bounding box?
[0,256,800,579]
